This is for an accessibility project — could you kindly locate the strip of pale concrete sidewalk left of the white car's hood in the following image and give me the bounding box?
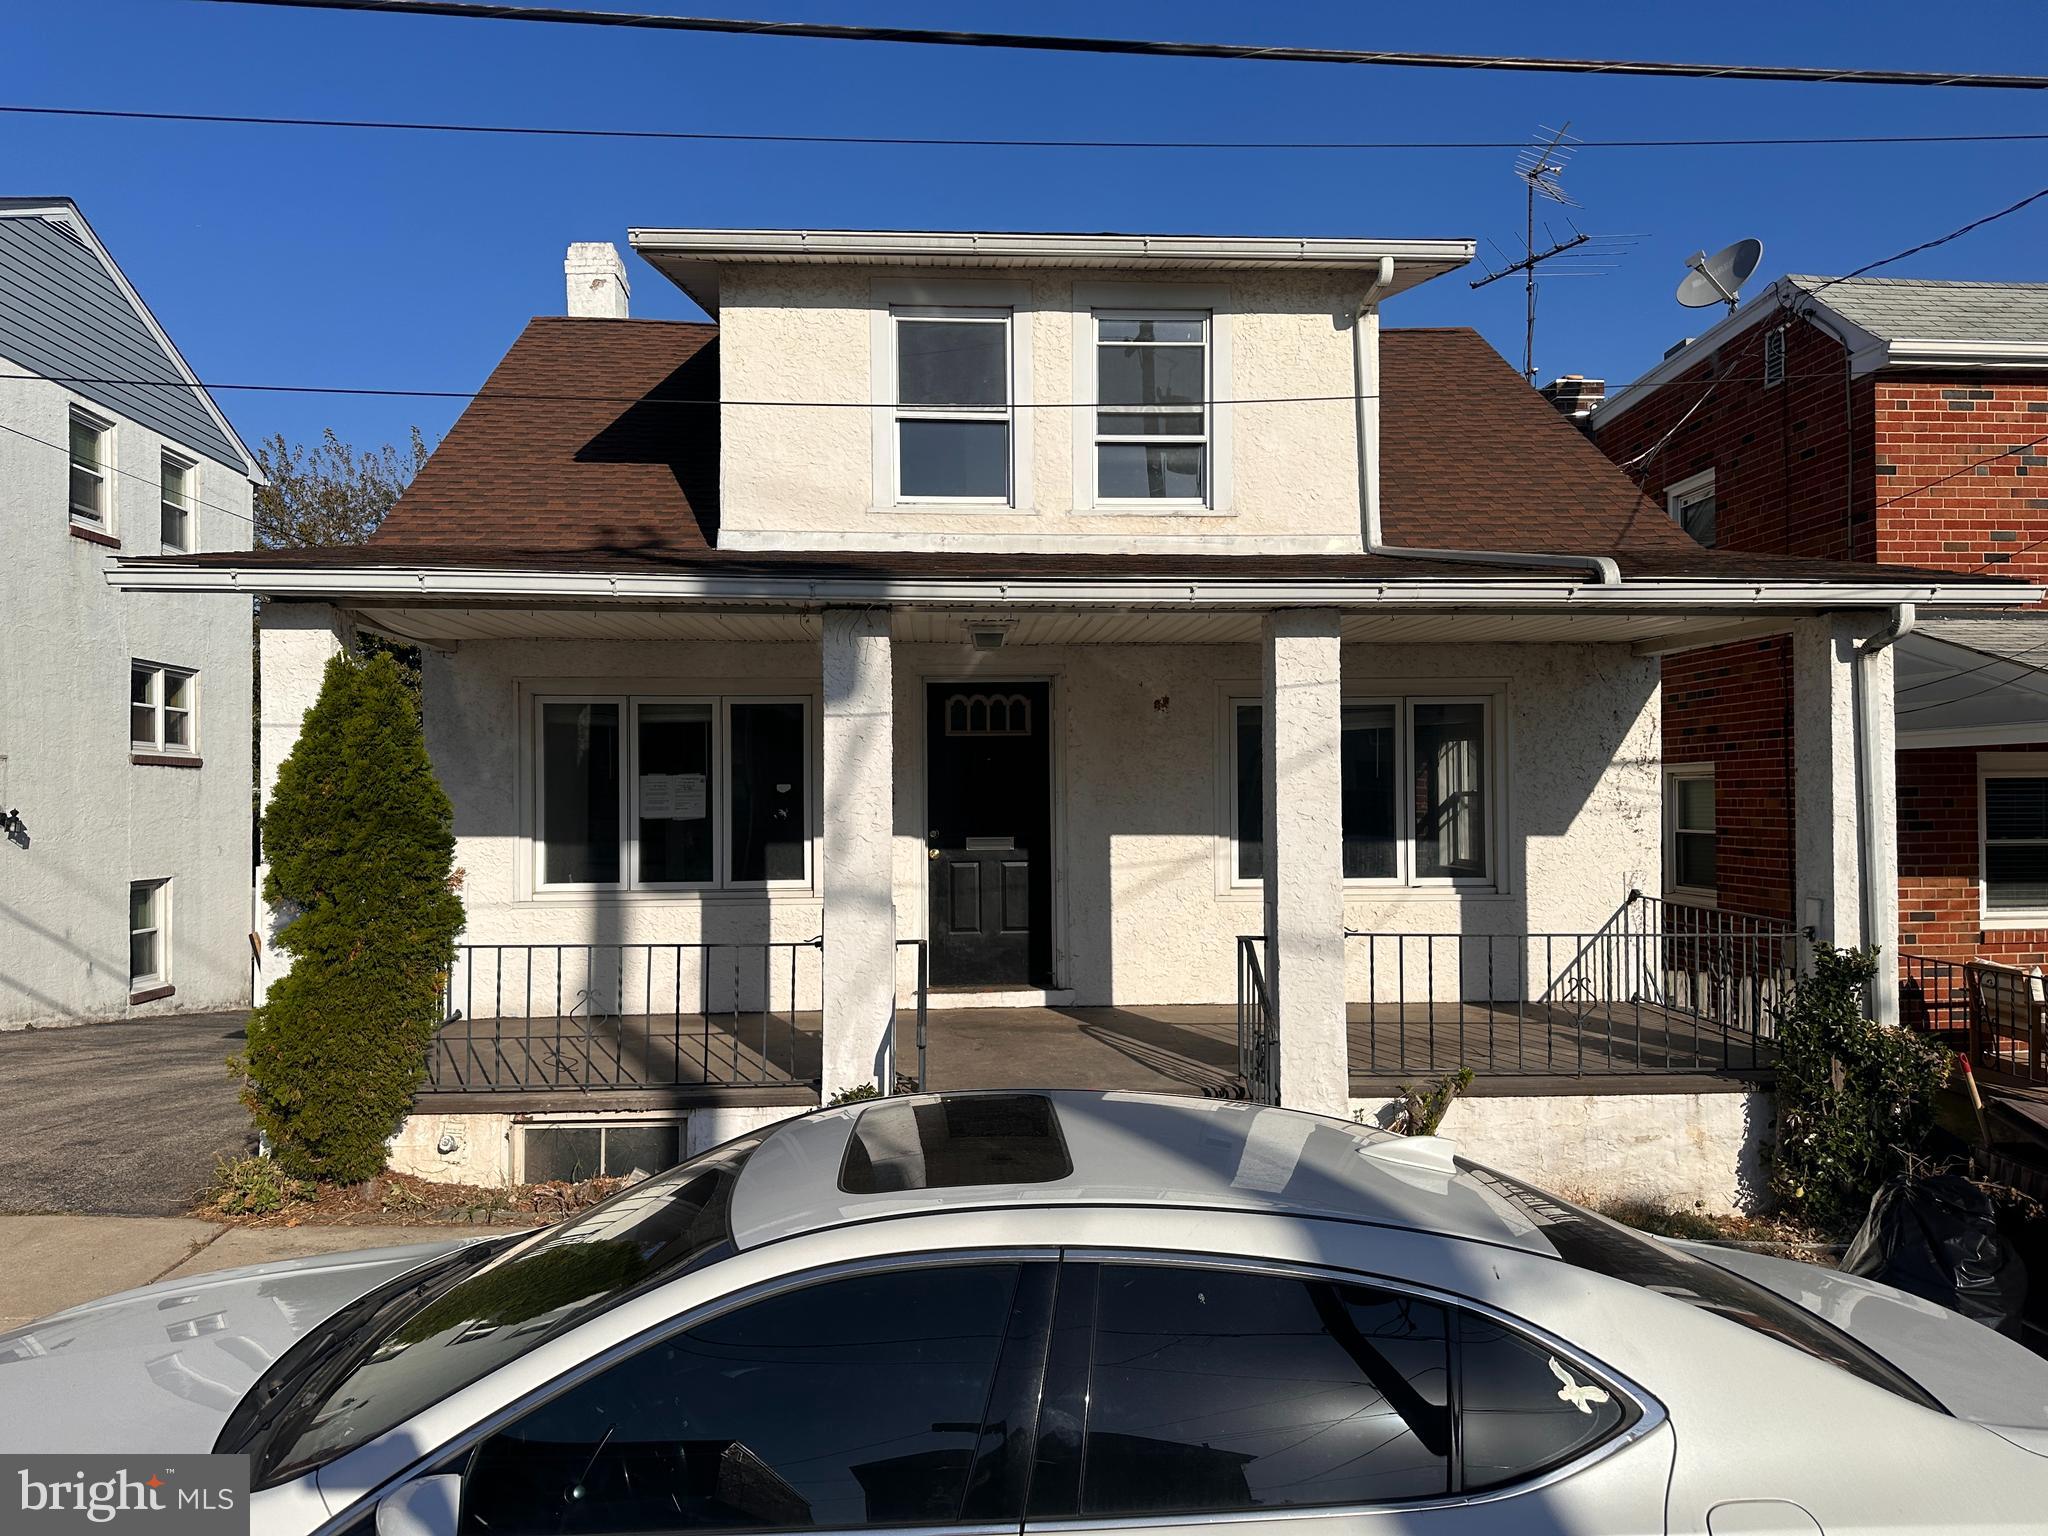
[0,1217,456,1333]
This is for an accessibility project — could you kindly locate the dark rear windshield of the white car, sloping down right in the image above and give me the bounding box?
[1458,1157,1946,1413]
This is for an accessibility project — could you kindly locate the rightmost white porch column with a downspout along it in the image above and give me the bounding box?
[1792,614,1898,1022]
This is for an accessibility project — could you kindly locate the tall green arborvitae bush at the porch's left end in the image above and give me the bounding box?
[236,653,463,1184]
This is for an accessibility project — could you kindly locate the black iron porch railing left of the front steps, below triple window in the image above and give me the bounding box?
[426,938,823,1094]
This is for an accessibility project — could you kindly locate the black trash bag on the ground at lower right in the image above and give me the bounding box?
[1841,1174,2028,1339]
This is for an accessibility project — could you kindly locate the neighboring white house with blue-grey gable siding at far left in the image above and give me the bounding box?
[0,199,260,1028]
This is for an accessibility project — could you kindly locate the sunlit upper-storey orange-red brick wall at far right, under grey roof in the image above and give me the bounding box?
[1876,373,2048,580]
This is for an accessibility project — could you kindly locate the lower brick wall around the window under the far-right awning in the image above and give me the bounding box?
[1898,748,2048,965]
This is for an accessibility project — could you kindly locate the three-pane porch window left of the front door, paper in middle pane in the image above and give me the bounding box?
[535,694,811,891]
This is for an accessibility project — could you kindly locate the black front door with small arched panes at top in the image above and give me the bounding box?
[926,678,1053,991]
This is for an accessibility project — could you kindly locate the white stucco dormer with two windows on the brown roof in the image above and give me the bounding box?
[631,229,1473,553]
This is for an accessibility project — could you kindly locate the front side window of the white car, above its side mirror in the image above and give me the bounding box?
[463,1264,1032,1536]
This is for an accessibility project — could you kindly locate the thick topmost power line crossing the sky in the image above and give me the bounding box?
[199,0,2048,90]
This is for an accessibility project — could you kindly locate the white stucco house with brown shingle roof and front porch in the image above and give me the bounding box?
[111,229,2038,1204]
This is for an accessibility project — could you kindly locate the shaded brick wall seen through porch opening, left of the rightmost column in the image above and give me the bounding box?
[1663,637,1792,920]
